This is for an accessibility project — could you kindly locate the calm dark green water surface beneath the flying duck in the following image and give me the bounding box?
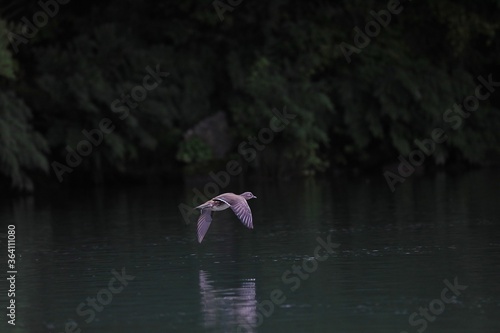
[0,171,500,333]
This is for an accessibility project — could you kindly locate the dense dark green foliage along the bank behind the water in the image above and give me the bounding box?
[0,0,500,190]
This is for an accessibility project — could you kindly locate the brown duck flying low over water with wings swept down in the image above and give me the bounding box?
[196,192,257,243]
